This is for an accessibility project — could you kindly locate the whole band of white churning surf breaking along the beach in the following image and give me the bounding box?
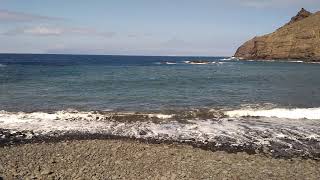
[0,108,320,158]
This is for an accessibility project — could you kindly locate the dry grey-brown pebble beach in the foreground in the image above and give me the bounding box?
[0,139,320,179]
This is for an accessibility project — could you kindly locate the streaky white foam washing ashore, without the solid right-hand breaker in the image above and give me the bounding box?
[0,111,320,157]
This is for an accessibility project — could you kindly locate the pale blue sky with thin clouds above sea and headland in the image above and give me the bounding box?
[0,0,320,56]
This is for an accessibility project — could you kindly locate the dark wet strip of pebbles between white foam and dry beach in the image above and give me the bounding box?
[0,129,320,162]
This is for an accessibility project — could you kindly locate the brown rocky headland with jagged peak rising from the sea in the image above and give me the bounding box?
[234,9,320,61]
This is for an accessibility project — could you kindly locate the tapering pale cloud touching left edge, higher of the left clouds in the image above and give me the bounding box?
[0,9,63,22]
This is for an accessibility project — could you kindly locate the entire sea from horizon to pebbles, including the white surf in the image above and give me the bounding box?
[0,54,320,158]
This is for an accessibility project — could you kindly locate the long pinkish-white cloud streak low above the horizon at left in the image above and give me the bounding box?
[3,25,116,37]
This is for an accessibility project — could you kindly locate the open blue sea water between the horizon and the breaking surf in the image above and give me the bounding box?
[0,54,320,111]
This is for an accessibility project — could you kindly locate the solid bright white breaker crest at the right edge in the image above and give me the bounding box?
[225,108,320,119]
